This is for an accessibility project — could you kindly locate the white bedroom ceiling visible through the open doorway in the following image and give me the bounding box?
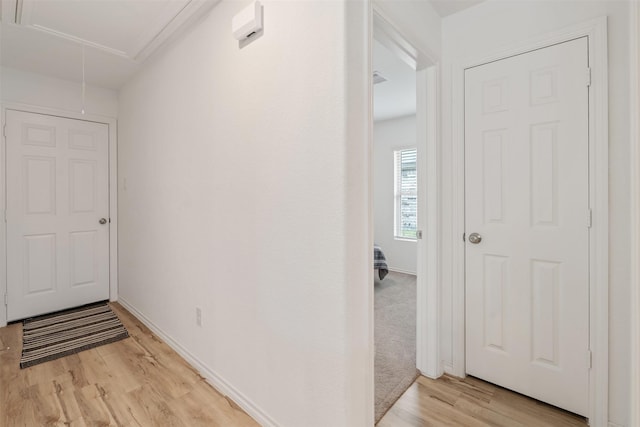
[373,40,416,120]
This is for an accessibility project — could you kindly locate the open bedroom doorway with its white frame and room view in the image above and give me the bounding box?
[371,8,442,422]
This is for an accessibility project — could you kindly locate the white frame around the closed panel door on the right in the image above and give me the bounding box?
[450,17,609,426]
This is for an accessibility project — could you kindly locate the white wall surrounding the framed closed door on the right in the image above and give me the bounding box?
[442,0,630,426]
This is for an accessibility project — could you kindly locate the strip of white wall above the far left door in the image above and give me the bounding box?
[1,67,118,118]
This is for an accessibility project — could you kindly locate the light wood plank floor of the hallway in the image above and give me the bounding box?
[0,304,587,427]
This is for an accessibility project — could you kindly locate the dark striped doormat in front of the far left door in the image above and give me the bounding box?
[20,302,129,369]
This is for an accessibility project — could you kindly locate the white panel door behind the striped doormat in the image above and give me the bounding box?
[6,110,109,321]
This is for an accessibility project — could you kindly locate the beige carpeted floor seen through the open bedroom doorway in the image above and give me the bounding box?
[374,272,418,423]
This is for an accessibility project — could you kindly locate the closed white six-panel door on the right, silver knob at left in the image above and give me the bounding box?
[465,38,590,415]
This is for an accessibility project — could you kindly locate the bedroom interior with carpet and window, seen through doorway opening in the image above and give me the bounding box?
[372,36,419,420]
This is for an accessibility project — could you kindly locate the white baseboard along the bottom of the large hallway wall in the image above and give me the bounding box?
[118,297,278,427]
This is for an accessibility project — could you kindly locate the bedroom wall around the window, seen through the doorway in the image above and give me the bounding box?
[373,115,417,274]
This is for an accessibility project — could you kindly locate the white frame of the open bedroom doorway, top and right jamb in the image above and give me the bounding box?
[369,3,443,378]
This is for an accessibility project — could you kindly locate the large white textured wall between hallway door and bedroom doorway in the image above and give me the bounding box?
[118,0,373,426]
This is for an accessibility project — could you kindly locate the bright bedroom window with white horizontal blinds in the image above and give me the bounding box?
[394,148,418,240]
